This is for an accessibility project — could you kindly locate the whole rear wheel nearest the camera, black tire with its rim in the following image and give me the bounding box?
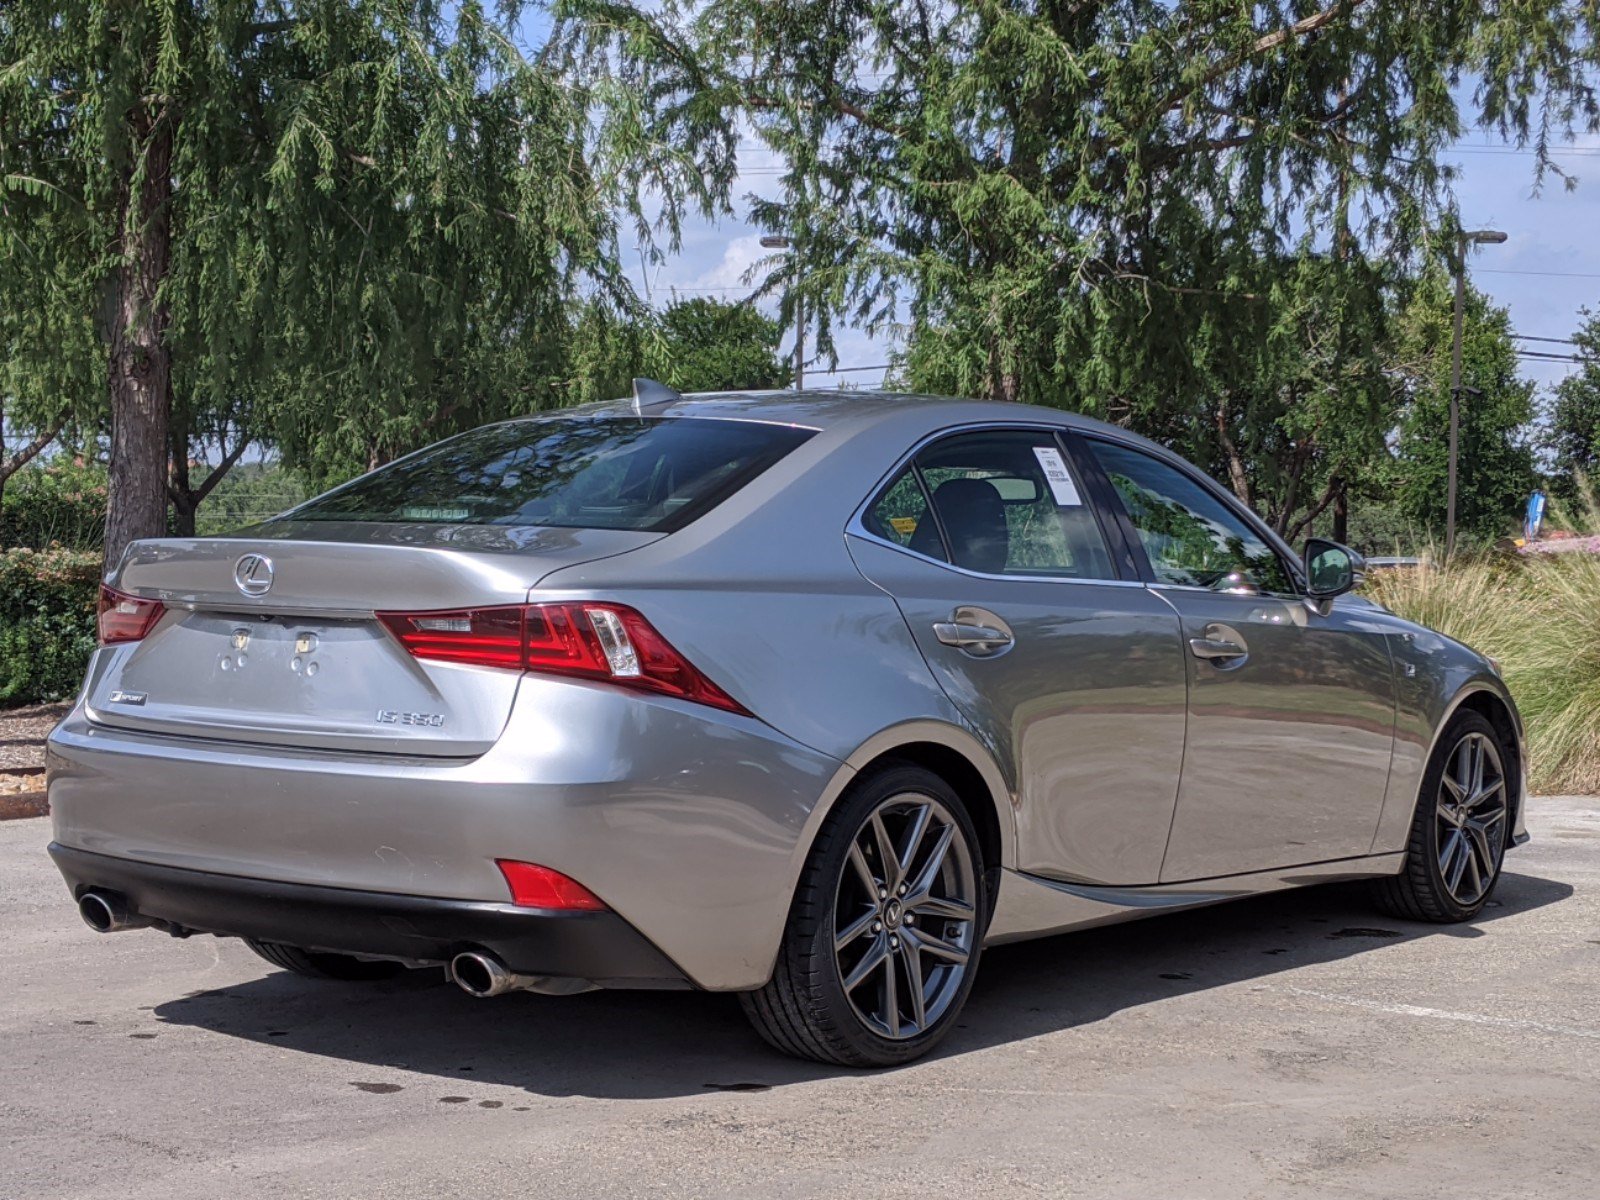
[739,765,989,1067]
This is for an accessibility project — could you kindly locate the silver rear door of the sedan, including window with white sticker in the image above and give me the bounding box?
[850,427,1186,883]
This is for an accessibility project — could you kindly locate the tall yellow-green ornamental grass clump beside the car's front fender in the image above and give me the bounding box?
[1368,552,1600,794]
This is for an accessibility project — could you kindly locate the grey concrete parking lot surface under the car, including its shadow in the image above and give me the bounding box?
[0,798,1600,1200]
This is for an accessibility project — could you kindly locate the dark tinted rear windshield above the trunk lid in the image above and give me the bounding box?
[283,418,813,533]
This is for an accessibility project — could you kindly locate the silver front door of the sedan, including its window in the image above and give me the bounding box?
[1083,437,1395,882]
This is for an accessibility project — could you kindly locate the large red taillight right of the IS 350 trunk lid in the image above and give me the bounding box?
[378,603,749,715]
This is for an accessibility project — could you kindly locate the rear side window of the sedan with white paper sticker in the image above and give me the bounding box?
[866,430,1117,579]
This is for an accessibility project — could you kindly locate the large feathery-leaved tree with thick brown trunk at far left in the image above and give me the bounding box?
[0,0,629,562]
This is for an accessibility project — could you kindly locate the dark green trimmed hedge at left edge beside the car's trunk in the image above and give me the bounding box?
[0,549,101,706]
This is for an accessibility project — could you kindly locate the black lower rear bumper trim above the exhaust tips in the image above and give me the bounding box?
[50,842,690,987]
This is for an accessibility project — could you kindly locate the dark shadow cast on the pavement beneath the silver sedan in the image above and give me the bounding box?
[155,872,1573,1101]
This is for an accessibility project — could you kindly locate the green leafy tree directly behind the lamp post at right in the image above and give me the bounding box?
[1390,272,1538,541]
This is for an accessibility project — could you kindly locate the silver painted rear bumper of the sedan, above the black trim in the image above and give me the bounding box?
[48,675,850,990]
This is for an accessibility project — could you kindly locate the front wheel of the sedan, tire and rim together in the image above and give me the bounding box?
[1373,712,1512,925]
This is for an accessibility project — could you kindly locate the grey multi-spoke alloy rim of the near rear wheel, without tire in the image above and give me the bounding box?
[834,794,978,1042]
